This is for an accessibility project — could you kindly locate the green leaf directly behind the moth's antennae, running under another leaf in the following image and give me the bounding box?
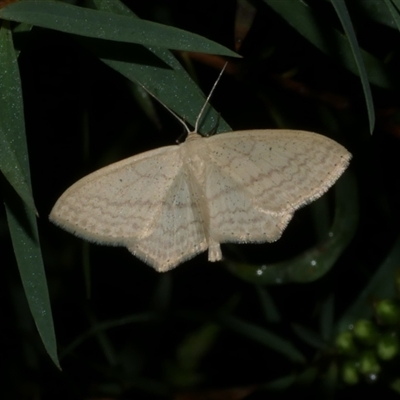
[85,0,232,133]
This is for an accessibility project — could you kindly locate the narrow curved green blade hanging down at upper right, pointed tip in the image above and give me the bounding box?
[331,0,375,133]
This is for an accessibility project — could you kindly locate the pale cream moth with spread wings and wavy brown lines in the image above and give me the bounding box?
[50,66,351,272]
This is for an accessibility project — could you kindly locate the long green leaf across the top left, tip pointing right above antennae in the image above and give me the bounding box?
[0,0,238,57]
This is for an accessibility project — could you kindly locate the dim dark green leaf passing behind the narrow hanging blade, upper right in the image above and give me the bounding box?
[264,0,397,89]
